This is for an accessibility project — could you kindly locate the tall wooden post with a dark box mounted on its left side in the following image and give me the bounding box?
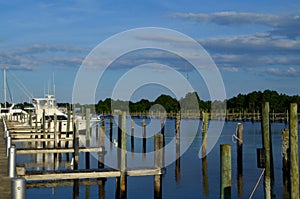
[262,102,274,199]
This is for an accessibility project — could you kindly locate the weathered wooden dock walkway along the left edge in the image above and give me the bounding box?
[0,120,11,198]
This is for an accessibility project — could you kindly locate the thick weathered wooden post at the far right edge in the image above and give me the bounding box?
[289,103,299,199]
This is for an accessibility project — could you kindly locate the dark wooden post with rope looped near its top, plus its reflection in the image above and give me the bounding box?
[236,123,244,197]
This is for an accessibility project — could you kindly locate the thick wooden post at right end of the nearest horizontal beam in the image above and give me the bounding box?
[154,134,163,199]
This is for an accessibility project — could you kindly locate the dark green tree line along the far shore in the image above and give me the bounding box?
[6,90,300,114]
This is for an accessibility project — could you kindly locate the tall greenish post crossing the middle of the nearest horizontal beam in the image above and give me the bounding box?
[120,112,127,198]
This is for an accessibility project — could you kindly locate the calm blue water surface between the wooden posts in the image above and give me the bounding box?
[21,118,298,199]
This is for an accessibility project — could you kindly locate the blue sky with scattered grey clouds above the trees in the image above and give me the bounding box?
[0,0,300,103]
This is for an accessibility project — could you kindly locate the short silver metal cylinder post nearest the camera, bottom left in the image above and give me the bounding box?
[11,178,26,199]
